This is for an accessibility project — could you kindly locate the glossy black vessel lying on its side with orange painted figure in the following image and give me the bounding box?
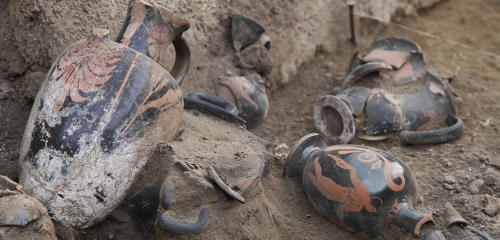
[286,133,432,239]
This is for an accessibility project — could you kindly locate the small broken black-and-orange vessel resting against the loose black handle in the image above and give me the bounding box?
[216,73,269,128]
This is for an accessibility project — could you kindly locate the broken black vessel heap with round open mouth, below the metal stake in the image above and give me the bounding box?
[314,38,463,144]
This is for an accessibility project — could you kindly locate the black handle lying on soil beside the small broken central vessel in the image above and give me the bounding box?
[184,93,246,123]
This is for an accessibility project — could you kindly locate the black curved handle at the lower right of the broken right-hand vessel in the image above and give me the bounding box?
[399,115,464,145]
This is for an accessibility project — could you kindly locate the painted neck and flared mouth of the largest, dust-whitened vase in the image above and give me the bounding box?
[116,0,189,64]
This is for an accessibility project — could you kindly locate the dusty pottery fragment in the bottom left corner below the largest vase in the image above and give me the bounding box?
[0,175,57,240]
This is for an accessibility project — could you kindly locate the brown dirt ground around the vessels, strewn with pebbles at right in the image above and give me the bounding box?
[0,0,500,240]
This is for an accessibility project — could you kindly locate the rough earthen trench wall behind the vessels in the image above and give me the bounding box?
[0,0,440,92]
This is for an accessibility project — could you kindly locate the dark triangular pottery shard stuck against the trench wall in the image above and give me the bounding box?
[231,14,265,52]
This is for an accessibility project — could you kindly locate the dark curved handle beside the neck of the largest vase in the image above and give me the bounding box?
[170,35,191,86]
